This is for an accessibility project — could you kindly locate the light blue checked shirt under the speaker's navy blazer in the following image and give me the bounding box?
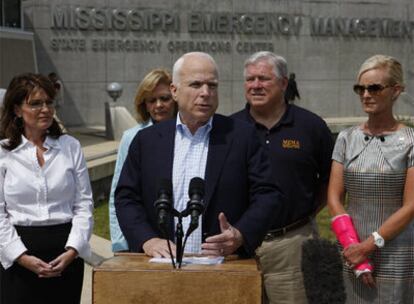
[173,115,213,253]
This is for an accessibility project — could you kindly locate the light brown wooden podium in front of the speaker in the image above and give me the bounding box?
[92,253,262,304]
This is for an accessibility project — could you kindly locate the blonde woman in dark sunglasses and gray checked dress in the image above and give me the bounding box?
[328,55,414,303]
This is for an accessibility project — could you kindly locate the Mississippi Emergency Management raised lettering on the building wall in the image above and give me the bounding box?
[50,5,414,54]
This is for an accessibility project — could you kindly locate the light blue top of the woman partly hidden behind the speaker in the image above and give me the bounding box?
[109,120,152,252]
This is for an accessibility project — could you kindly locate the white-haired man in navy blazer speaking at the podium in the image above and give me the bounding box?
[115,52,282,257]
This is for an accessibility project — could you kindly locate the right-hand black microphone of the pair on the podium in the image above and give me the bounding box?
[187,177,204,235]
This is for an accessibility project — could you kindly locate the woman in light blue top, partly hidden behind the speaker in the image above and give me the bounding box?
[109,69,177,252]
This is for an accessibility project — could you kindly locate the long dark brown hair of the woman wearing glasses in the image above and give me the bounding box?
[0,73,62,151]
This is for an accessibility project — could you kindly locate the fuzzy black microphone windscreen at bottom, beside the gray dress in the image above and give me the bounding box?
[302,239,346,304]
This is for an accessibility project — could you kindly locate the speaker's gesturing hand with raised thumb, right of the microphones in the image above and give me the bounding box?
[201,212,243,256]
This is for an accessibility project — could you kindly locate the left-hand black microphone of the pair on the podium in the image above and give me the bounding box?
[154,179,172,234]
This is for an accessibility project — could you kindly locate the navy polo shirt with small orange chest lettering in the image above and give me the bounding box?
[231,104,334,229]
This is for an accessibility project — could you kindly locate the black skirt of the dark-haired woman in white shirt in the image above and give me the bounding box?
[0,223,84,304]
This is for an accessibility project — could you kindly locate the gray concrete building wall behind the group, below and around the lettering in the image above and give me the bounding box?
[23,0,414,125]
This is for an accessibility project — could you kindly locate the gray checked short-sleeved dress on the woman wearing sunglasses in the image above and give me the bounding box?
[332,127,414,304]
